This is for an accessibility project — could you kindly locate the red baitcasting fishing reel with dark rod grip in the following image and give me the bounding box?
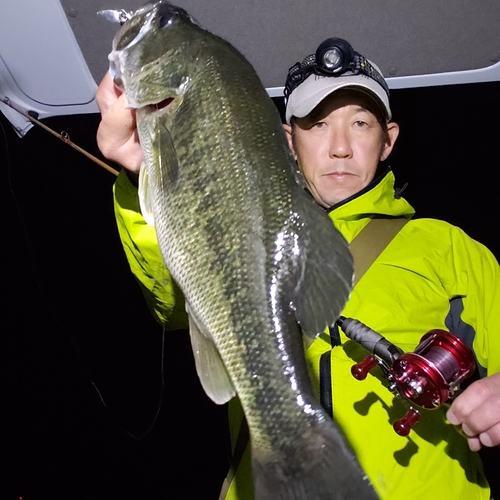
[338,317,475,436]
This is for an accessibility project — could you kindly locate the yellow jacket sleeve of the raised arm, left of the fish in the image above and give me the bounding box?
[113,170,187,330]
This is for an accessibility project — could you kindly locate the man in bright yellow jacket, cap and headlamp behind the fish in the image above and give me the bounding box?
[97,39,500,500]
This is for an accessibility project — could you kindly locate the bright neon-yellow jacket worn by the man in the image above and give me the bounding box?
[115,171,500,500]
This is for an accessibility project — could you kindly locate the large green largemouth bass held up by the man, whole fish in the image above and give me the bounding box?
[110,1,376,500]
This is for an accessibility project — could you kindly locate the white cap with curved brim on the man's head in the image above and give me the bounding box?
[285,61,392,124]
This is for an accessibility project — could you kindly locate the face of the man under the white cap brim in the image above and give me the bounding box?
[285,90,399,208]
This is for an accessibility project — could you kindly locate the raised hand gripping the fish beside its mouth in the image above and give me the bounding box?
[96,73,143,173]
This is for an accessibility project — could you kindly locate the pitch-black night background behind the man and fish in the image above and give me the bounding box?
[0,82,500,500]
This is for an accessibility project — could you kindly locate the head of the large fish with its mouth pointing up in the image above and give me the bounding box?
[108,0,200,108]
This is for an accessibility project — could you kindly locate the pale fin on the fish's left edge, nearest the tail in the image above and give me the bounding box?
[186,306,236,404]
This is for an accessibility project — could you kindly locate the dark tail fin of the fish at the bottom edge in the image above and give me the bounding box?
[252,420,378,500]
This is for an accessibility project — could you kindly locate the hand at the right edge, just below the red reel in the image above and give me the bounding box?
[446,373,500,451]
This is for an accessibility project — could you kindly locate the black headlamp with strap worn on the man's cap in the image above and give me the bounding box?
[284,38,389,100]
